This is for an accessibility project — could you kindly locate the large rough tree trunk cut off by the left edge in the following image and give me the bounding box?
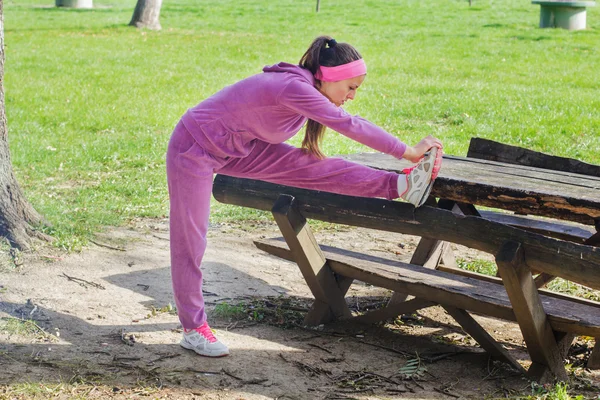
[0,0,44,250]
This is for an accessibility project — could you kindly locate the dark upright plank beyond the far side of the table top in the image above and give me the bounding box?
[467,137,600,176]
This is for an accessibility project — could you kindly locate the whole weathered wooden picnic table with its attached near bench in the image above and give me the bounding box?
[213,149,600,381]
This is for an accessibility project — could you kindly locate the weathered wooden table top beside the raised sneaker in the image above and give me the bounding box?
[341,153,600,225]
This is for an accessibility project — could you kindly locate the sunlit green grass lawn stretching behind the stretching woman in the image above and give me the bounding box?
[4,0,600,249]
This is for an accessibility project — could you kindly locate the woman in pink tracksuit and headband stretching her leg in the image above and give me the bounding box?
[167,36,442,357]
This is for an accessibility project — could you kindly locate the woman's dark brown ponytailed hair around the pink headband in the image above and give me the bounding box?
[300,36,362,159]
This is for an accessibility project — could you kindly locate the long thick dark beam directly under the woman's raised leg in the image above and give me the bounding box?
[213,175,600,289]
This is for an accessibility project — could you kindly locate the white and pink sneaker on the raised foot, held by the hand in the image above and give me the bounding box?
[398,147,442,207]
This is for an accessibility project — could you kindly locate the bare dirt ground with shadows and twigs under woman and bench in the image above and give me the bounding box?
[0,220,600,400]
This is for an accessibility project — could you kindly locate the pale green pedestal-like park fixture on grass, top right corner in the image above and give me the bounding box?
[531,0,596,30]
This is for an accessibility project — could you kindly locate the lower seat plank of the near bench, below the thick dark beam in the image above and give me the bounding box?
[255,240,600,337]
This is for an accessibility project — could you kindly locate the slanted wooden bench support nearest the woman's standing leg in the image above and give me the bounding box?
[272,195,352,325]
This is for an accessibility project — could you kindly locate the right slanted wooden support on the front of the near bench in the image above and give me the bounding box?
[496,242,573,382]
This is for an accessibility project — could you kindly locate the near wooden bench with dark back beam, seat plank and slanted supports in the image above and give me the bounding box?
[213,175,600,382]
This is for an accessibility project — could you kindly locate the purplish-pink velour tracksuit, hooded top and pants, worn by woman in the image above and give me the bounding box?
[167,63,406,329]
